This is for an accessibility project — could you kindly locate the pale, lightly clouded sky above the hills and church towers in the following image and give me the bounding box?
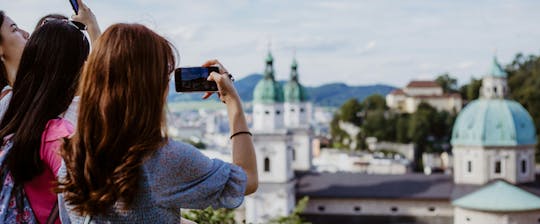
[4,0,540,87]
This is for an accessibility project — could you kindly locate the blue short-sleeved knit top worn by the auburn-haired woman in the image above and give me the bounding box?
[59,141,247,224]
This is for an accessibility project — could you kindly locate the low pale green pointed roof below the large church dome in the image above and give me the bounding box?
[452,180,540,212]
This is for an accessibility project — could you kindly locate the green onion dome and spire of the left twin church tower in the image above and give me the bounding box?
[253,52,283,104]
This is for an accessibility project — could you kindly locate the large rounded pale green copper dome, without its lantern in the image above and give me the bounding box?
[451,99,536,146]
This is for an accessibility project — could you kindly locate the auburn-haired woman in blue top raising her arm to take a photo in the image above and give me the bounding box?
[58,24,258,223]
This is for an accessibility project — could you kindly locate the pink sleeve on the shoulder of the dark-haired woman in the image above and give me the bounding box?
[40,118,74,175]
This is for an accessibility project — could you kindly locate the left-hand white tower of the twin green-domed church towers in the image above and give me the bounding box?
[245,52,295,223]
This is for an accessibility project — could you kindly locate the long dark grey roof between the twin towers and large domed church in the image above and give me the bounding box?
[295,172,540,201]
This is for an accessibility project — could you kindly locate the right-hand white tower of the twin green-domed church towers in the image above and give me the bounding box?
[283,58,313,171]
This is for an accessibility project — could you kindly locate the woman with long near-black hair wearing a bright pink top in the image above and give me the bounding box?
[0,20,90,223]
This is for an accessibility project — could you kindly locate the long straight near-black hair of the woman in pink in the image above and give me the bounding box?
[0,21,90,184]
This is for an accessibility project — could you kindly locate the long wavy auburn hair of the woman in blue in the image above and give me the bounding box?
[58,24,175,215]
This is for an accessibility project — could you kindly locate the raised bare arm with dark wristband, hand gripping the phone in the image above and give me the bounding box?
[203,60,259,195]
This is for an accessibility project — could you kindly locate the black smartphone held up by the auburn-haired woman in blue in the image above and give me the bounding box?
[174,67,219,92]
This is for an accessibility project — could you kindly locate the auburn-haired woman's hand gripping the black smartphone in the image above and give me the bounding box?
[202,59,240,104]
